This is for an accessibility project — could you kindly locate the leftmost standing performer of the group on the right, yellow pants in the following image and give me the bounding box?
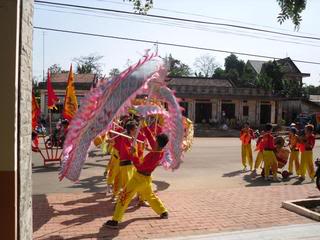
[240,123,254,171]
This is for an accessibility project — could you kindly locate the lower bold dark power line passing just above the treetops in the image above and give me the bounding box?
[34,26,320,65]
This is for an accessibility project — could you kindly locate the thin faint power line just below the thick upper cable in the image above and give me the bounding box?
[36,7,320,47]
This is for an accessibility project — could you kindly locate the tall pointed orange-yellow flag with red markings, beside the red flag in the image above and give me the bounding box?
[63,65,78,120]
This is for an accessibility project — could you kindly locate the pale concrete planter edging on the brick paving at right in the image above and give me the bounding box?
[282,198,320,221]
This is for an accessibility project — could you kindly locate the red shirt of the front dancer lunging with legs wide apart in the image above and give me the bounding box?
[132,125,164,174]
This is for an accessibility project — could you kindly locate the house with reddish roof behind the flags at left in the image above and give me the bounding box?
[39,73,96,120]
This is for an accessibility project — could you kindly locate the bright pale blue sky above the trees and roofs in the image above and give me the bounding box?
[33,0,320,86]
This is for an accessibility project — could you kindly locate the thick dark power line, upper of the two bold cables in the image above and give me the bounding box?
[35,0,320,40]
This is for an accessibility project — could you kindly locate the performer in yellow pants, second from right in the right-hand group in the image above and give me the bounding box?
[288,127,300,175]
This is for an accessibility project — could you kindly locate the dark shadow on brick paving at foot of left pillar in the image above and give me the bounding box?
[32,195,56,232]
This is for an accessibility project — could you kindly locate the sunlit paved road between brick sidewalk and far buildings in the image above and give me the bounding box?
[32,138,320,194]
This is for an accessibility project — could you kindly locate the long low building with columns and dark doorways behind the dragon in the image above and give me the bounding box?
[168,77,282,126]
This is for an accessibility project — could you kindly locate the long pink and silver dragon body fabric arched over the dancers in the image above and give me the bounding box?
[60,55,184,181]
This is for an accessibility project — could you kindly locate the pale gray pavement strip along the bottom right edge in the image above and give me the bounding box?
[158,223,320,240]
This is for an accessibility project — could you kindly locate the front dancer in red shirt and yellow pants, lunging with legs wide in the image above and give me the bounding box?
[104,120,169,228]
